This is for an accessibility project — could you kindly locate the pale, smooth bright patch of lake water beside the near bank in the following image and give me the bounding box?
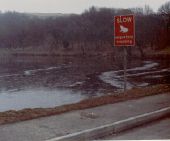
[0,88,86,111]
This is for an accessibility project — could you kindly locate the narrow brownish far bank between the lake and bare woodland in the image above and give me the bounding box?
[0,47,170,59]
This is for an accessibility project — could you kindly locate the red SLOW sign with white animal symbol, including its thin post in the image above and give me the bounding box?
[114,15,135,93]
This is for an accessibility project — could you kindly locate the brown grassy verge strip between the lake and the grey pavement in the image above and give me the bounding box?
[0,85,170,124]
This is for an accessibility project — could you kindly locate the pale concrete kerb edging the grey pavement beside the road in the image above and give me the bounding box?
[46,107,170,141]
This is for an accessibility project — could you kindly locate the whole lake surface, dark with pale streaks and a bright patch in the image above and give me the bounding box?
[0,56,170,111]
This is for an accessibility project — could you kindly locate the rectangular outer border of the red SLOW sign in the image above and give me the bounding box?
[114,14,136,47]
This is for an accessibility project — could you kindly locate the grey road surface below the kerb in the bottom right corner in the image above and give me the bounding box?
[101,117,170,140]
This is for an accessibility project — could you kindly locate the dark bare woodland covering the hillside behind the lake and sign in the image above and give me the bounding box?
[0,2,170,54]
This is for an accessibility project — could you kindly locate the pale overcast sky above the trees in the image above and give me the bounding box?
[0,0,170,13]
